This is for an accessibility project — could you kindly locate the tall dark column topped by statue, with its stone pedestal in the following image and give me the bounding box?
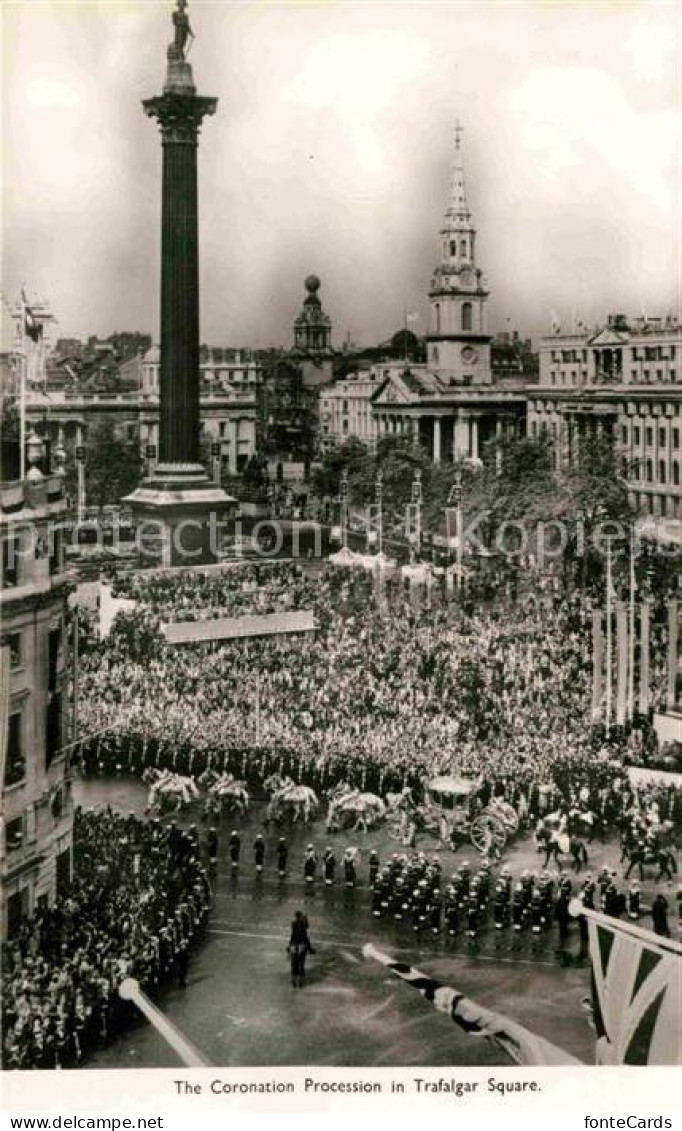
[127,0,235,566]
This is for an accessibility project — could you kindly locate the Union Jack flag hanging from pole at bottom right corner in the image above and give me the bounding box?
[587,917,682,1065]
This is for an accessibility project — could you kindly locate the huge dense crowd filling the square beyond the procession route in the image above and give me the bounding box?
[79,563,678,804]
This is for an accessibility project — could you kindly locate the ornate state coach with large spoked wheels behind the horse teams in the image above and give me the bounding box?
[390,777,519,856]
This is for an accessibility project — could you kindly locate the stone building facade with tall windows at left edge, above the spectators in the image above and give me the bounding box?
[0,468,72,938]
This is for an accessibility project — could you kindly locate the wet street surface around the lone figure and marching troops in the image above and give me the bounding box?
[76,779,618,1069]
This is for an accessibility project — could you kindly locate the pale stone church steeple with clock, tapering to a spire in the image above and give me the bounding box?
[426,123,492,386]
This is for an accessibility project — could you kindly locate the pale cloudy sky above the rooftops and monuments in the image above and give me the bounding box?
[3,0,682,346]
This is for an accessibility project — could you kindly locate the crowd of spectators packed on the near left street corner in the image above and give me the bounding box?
[2,809,211,1069]
